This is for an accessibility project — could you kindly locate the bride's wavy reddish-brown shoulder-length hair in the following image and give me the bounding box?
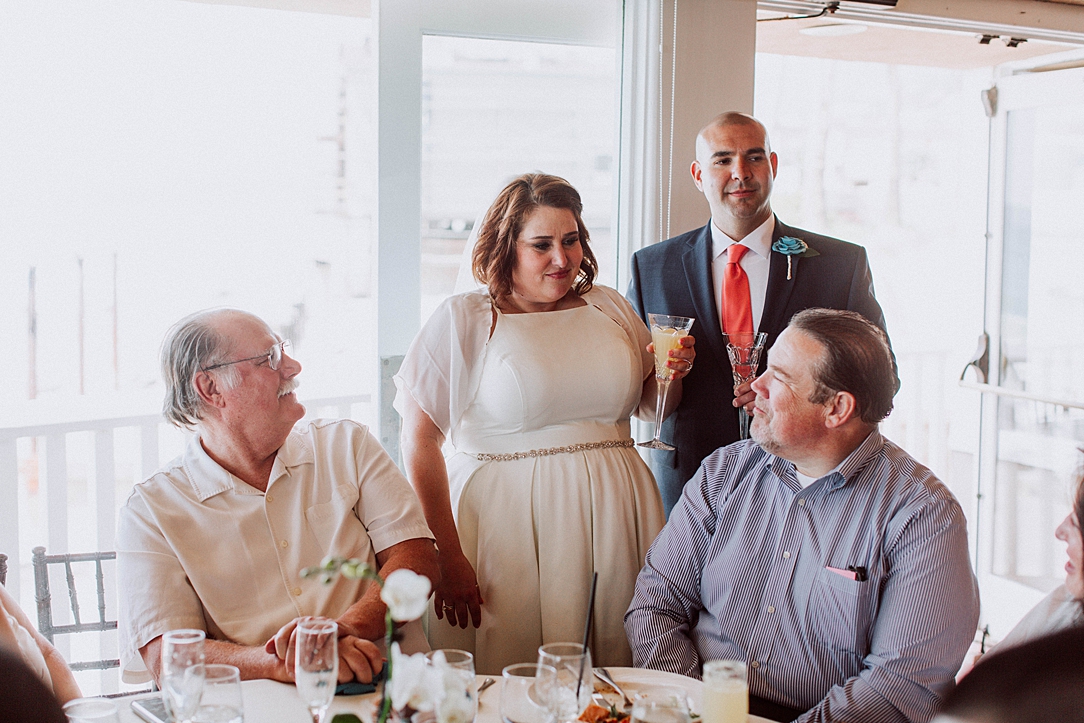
[470,173,598,299]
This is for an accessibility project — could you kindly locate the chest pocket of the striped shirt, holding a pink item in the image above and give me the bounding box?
[810,569,872,659]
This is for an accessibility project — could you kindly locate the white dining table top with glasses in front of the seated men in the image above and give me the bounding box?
[117,668,771,723]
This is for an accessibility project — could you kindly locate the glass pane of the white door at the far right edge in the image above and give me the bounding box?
[992,103,1084,590]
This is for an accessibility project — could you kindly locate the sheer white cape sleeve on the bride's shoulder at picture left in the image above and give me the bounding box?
[393,289,493,438]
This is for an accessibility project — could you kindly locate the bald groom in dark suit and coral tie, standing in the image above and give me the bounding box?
[627,113,885,516]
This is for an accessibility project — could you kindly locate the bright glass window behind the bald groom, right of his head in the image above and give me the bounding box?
[756,53,990,513]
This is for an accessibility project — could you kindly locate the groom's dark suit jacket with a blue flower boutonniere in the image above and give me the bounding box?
[627,218,885,515]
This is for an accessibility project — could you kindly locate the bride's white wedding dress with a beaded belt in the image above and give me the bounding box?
[396,287,666,674]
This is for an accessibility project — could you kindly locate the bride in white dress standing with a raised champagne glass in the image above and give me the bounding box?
[396,173,695,674]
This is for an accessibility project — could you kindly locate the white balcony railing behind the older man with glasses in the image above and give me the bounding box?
[0,395,375,694]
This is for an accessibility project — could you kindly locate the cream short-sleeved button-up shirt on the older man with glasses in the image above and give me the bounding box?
[117,419,433,682]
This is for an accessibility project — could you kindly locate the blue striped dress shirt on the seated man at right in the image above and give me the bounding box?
[624,430,979,723]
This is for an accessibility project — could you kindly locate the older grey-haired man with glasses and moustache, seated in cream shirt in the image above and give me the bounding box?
[117,310,438,682]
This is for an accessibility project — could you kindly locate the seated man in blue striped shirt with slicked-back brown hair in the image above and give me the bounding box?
[624,309,979,723]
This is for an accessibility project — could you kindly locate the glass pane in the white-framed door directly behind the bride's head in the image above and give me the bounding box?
[422,36,618,322]
